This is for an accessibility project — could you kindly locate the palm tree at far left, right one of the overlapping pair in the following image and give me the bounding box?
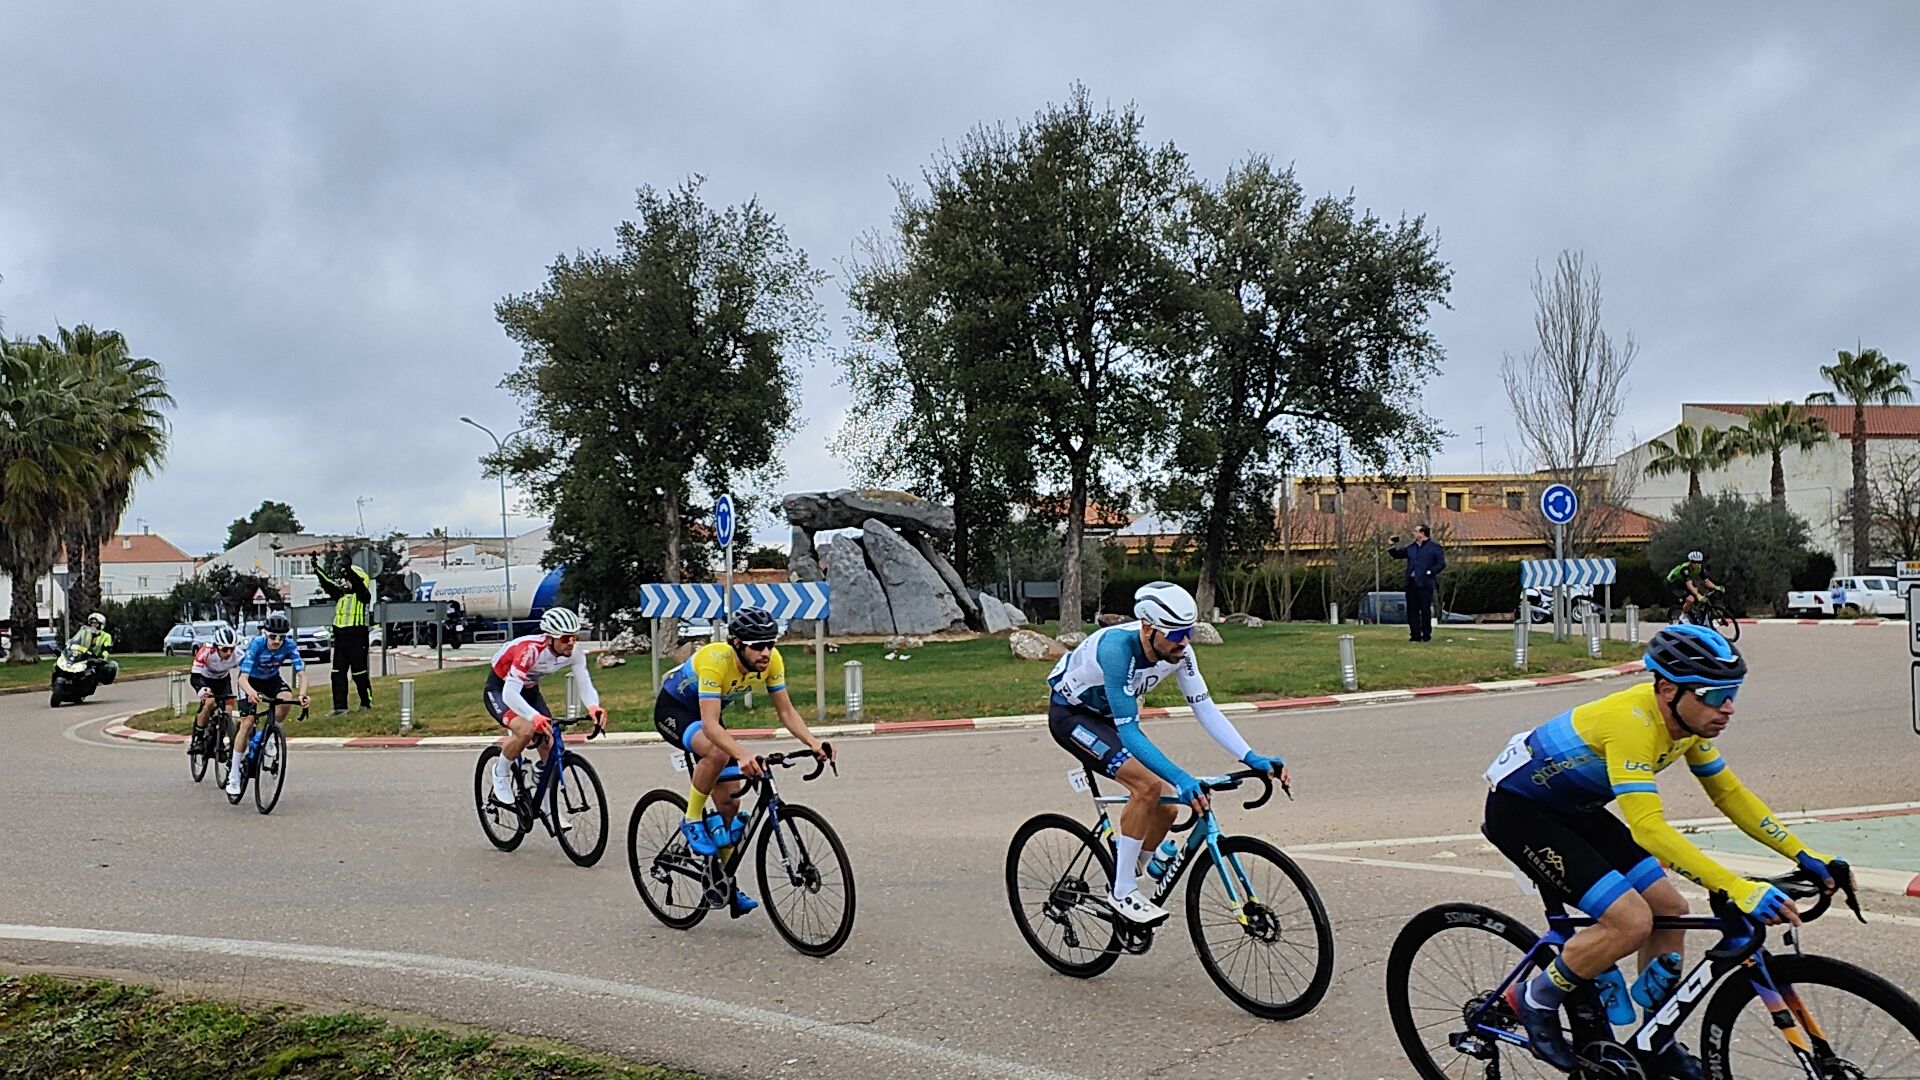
[40,325,173,611]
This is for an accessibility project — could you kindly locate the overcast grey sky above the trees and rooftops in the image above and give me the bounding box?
[0,0,1920,553]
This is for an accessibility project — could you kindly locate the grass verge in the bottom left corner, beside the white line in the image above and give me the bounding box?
[0,974,695,1080]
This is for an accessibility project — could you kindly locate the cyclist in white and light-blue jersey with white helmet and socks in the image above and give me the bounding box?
[1046,580,1292,926]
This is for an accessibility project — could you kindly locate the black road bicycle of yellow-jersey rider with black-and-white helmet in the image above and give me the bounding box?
[626,744,854,957]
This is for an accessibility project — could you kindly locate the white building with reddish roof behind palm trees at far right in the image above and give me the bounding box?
[1613,404,1920,575]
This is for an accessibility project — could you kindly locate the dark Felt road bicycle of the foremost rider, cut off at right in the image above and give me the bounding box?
[1386,861,1920,1080]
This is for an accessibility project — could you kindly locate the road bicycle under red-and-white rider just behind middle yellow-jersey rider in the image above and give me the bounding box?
[474,719,607,867]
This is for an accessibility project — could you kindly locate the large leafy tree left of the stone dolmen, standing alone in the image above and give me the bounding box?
[488,179,822,617]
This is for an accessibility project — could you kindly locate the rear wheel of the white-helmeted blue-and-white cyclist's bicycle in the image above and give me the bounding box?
[1006,813,1119,978]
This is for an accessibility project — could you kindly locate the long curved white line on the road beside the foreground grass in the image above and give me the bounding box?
[0,924,1081,1080]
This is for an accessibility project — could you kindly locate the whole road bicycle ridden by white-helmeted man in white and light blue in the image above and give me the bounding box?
[1006,767,1332,1020]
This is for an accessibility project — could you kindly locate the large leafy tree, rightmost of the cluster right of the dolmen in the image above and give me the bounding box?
[1171,158,1450,611]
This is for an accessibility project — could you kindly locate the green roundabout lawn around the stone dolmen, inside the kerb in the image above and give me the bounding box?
[134,623,1640,736]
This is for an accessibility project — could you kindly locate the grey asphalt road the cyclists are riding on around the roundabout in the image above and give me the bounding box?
[0,626,1920,1078]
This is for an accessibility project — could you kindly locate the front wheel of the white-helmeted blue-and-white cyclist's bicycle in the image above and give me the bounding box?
[1187,836,1332,1020]
